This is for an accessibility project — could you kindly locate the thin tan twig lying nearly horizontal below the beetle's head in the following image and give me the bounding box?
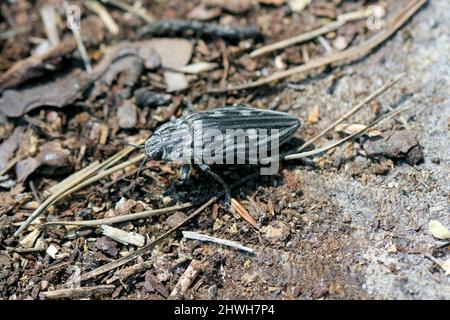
[44,202,193,227]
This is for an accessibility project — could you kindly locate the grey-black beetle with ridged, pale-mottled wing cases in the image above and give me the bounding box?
[143,104,302,204]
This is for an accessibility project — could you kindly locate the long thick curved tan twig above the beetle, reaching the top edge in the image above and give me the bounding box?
[208,0,428,93]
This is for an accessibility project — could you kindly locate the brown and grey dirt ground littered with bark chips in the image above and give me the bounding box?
[0,0,450,299]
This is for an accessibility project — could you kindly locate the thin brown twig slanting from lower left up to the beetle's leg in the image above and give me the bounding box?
[80,174,254,281]
